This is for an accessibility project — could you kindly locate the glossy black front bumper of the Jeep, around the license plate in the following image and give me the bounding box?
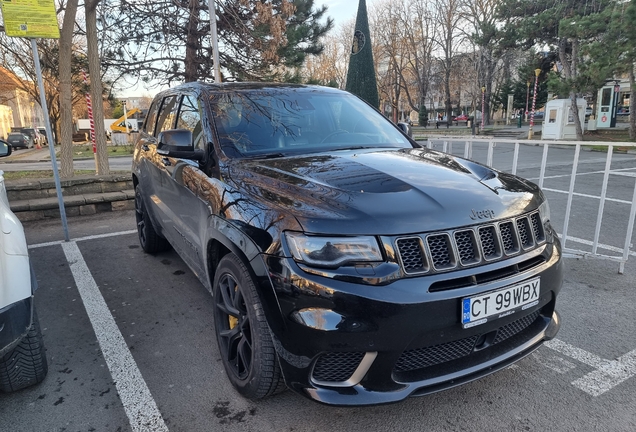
[264,240,563,405]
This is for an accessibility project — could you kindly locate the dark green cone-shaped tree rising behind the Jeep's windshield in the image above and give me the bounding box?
[345,0,380,108]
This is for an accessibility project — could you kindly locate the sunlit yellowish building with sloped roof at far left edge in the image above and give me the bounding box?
[0,66,44,138]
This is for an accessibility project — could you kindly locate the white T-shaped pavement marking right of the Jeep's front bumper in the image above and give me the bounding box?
[545,339,636,396]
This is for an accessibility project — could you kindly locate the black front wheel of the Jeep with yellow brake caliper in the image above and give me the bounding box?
[213,254,285,400]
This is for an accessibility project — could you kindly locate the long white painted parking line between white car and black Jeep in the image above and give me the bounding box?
[62,243,168,432]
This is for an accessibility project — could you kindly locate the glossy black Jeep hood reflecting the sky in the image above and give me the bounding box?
[228,149,543,235]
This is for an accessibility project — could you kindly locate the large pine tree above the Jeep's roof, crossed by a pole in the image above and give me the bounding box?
[99,0,333,85]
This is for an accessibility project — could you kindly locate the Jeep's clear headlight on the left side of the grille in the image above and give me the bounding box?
[285,232,382,268]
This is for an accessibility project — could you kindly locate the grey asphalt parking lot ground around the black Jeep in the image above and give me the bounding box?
[0,146,636,431]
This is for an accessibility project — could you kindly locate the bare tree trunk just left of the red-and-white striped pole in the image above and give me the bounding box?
[86,0,110,175]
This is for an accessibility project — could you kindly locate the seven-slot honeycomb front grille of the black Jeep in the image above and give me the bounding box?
[396,212,546,275]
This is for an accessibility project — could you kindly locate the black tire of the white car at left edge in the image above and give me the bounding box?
[0,309,49,393]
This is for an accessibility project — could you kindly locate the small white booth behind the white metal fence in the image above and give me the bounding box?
[541,98,587,140]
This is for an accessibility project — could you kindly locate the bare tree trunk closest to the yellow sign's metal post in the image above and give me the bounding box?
[58,0,78,178]
